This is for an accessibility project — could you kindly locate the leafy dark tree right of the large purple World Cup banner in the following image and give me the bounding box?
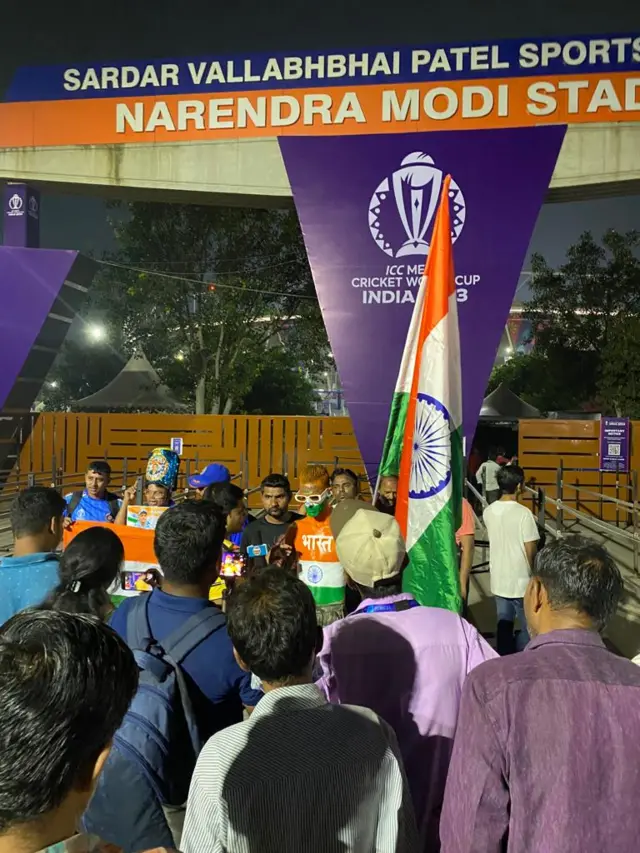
[490,226,640,411]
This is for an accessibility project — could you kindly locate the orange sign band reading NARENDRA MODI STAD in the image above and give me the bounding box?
[0,72,640,148]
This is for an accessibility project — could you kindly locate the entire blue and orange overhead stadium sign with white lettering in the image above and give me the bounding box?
[0,35,640,147]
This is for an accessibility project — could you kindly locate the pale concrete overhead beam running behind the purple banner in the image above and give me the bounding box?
[0,123,640,207]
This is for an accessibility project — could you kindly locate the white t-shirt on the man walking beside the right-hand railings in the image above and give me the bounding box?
[482,500,540,598]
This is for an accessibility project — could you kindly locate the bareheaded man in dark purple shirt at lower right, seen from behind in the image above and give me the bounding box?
[440,536,640,853]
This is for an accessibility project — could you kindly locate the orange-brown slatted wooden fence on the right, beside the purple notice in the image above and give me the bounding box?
[518,420,640,524]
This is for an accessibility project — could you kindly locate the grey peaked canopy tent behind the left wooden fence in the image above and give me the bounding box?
[72,352,189,412]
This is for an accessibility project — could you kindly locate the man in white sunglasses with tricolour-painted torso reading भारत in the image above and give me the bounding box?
[293,465,346,625]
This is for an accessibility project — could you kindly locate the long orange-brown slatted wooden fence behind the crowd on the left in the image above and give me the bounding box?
[15,412,365,500]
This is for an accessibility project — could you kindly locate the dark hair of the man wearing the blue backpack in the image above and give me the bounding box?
[153,501,226,584]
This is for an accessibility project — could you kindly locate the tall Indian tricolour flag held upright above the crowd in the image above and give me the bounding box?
[380,176,463,611]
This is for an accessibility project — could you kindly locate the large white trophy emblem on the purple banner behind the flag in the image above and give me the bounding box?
[369,151,467,258]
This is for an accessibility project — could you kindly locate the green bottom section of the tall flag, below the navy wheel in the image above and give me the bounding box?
[402,501,462,613]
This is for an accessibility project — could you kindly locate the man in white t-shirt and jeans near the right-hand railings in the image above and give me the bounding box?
[483,465,540,655]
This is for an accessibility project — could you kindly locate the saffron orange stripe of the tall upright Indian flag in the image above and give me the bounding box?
[396,175,455,537]
